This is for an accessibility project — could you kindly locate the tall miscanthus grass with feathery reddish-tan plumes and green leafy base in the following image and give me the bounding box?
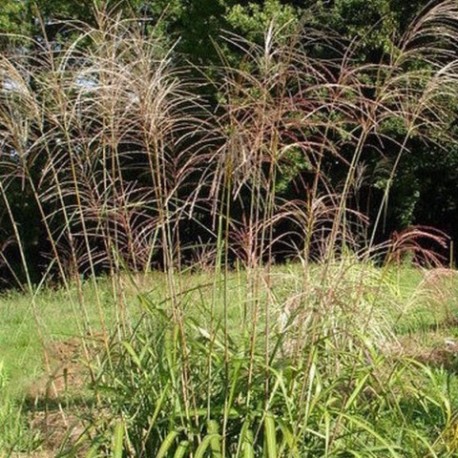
[0,1,458,457]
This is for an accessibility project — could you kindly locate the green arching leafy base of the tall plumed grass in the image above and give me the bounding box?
[82,262,456,457]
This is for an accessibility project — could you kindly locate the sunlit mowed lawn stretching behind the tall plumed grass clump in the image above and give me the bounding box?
[0,261,458,456]
